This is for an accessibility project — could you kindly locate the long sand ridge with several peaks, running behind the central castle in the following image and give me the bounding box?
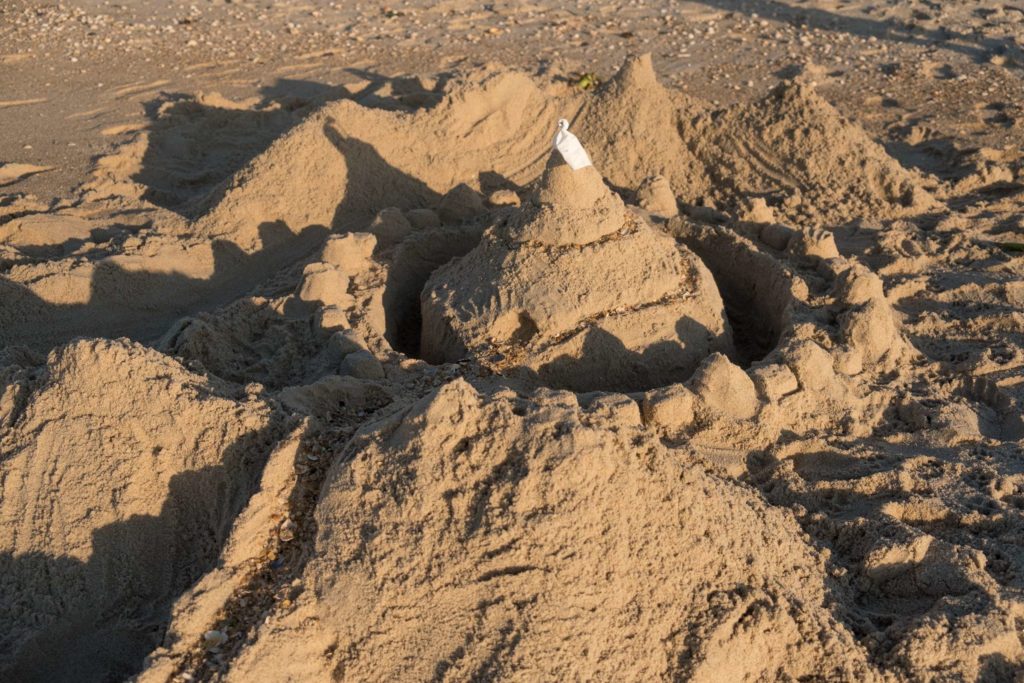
[0,56,929,350]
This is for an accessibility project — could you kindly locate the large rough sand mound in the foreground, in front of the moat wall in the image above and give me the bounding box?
[220,381,870,681]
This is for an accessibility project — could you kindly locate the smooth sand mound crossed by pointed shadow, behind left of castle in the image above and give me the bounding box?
[196,68,558,249]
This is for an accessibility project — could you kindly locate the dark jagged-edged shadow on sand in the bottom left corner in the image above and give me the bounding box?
[0,421,281,683]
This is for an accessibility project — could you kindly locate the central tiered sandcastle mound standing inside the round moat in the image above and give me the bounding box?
[421,156,731,391]
